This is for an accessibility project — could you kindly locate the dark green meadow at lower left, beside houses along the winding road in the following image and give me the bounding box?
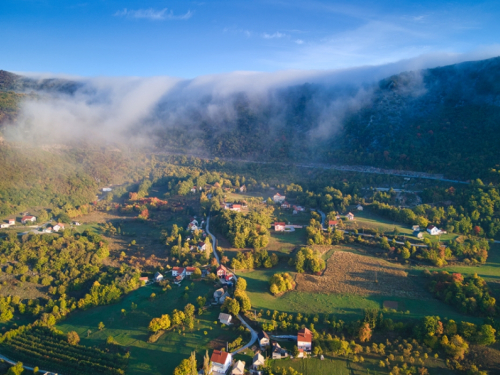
[57,282,238,375]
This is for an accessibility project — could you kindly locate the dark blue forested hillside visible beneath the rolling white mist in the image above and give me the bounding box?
[0,58,500,182]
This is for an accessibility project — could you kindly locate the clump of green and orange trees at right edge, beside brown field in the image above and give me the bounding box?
[427,271,496,316]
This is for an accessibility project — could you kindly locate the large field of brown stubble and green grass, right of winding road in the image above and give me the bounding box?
[242,245,480,323]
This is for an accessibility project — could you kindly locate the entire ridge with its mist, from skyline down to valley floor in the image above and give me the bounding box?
[0,54,500,180]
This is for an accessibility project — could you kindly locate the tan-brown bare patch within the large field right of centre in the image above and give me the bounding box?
[296,251,430,299]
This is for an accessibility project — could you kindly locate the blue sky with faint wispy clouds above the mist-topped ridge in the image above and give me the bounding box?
[0,0,500,78]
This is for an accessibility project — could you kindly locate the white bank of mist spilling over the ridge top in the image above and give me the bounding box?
[5,48,500,151]
